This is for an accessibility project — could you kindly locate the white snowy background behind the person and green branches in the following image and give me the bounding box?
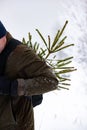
[0,0,87,130]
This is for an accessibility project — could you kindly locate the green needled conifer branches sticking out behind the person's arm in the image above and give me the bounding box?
[22,21,76,89]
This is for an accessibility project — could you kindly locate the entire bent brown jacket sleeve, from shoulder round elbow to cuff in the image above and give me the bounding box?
[5,45,58,96]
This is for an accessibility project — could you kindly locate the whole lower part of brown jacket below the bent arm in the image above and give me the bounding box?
[0,96,34,130]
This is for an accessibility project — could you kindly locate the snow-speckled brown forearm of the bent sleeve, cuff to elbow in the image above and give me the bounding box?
[17,77,58,96]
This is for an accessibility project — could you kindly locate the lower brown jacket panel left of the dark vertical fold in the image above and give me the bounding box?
[0,95,15,130]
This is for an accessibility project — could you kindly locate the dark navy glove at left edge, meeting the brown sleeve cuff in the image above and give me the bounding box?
[0,76,18,96]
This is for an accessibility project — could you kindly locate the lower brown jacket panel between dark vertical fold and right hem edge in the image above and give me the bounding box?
[12,96,34,130]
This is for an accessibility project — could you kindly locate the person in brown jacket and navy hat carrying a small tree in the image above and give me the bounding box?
[0,22,58,130]
